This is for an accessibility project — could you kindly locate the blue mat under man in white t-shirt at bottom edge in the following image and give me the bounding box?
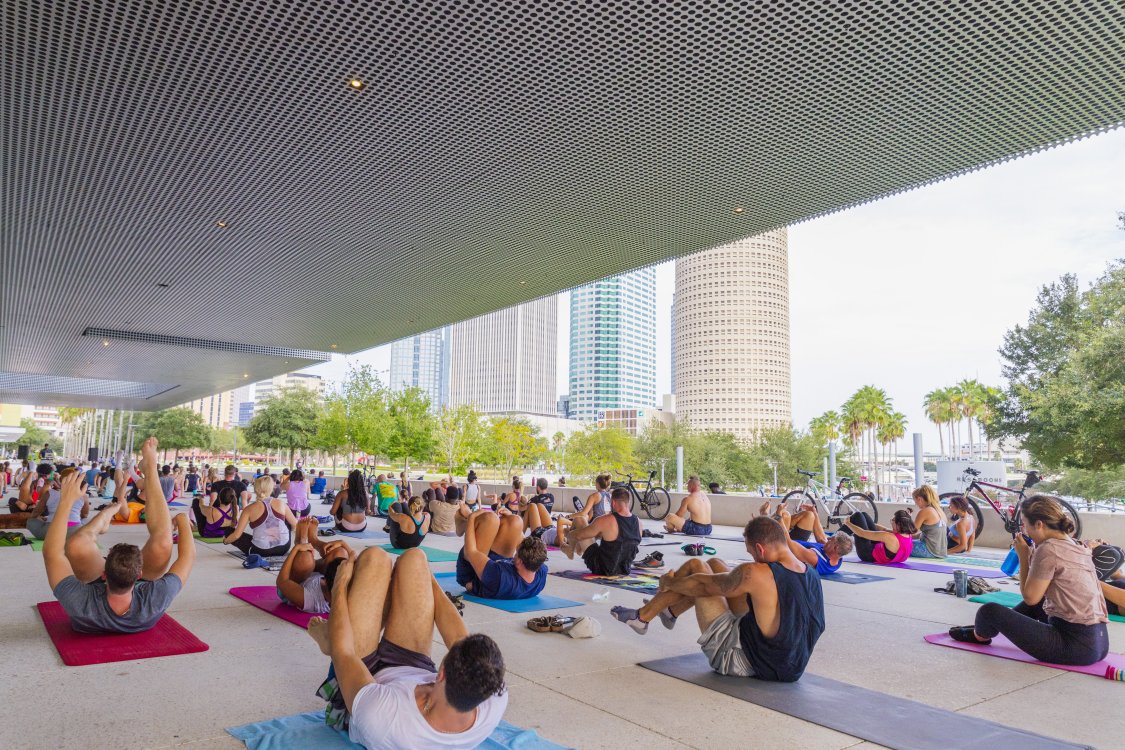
[226,711,567,750]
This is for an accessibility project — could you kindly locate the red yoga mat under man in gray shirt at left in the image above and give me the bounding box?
[35,602,208,667]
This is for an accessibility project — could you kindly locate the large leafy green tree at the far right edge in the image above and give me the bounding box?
[988,261,1125,470]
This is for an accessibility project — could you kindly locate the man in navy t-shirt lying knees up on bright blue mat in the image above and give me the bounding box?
[457,508,547,599]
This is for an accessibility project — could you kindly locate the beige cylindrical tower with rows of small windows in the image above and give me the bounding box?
[673,228,793,439]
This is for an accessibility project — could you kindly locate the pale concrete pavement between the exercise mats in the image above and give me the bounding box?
[0,501,1125,750]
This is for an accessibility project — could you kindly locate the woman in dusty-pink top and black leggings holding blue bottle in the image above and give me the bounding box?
[950,495,1109,667]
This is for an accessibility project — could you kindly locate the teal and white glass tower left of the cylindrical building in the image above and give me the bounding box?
[569,268,656,422]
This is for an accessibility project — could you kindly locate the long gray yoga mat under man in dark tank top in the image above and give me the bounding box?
[640,652,1094,750]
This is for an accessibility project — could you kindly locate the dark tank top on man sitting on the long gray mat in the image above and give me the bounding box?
[738,562,825,683]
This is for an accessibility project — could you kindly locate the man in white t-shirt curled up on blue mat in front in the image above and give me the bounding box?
[308,548,507,750]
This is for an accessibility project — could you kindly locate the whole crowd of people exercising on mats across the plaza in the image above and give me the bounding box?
[0,439,1125,748]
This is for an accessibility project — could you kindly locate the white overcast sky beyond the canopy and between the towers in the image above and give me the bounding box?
[311,129,1125,451]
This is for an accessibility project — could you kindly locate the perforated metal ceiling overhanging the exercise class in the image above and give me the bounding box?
[0,0,1125,408]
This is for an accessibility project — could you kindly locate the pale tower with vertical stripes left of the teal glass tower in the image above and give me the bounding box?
[447,295,558,416]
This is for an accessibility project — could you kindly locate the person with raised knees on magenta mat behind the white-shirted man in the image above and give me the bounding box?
[277,518,356,615]
